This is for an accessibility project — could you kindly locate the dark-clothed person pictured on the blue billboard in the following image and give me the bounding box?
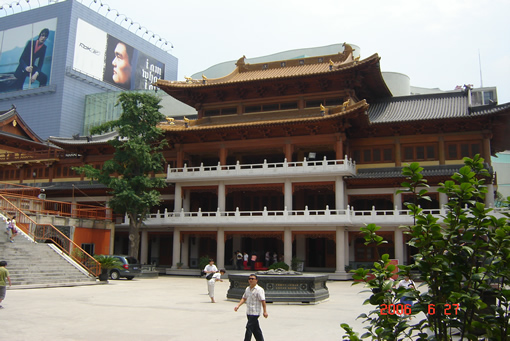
[14,28,50,90]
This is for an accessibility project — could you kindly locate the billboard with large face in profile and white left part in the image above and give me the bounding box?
[73,19,165,90]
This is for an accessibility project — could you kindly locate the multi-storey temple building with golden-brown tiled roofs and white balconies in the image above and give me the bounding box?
[0,44,510,279]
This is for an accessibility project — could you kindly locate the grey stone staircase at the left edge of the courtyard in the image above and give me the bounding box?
[0,224,98,289]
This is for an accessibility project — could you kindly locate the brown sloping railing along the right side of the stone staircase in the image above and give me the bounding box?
[0,194,101,277]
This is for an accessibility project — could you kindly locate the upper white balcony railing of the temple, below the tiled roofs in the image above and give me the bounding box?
[167,157,356,182]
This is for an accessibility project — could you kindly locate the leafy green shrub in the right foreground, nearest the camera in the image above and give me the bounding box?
[341,155,510,341]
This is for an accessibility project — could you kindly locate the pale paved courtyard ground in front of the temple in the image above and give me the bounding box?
[0,276,370,341]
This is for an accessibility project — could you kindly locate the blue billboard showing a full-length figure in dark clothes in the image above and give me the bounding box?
[0,18,57,92]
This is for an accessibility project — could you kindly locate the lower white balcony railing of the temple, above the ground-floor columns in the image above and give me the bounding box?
[121,207,510,228]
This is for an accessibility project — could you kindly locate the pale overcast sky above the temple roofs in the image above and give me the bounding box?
[82,0,504,104]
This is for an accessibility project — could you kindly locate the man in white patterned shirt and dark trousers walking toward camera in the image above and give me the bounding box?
[234,274,269,341]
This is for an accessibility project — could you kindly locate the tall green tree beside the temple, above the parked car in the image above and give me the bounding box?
[75,92,167,258]
